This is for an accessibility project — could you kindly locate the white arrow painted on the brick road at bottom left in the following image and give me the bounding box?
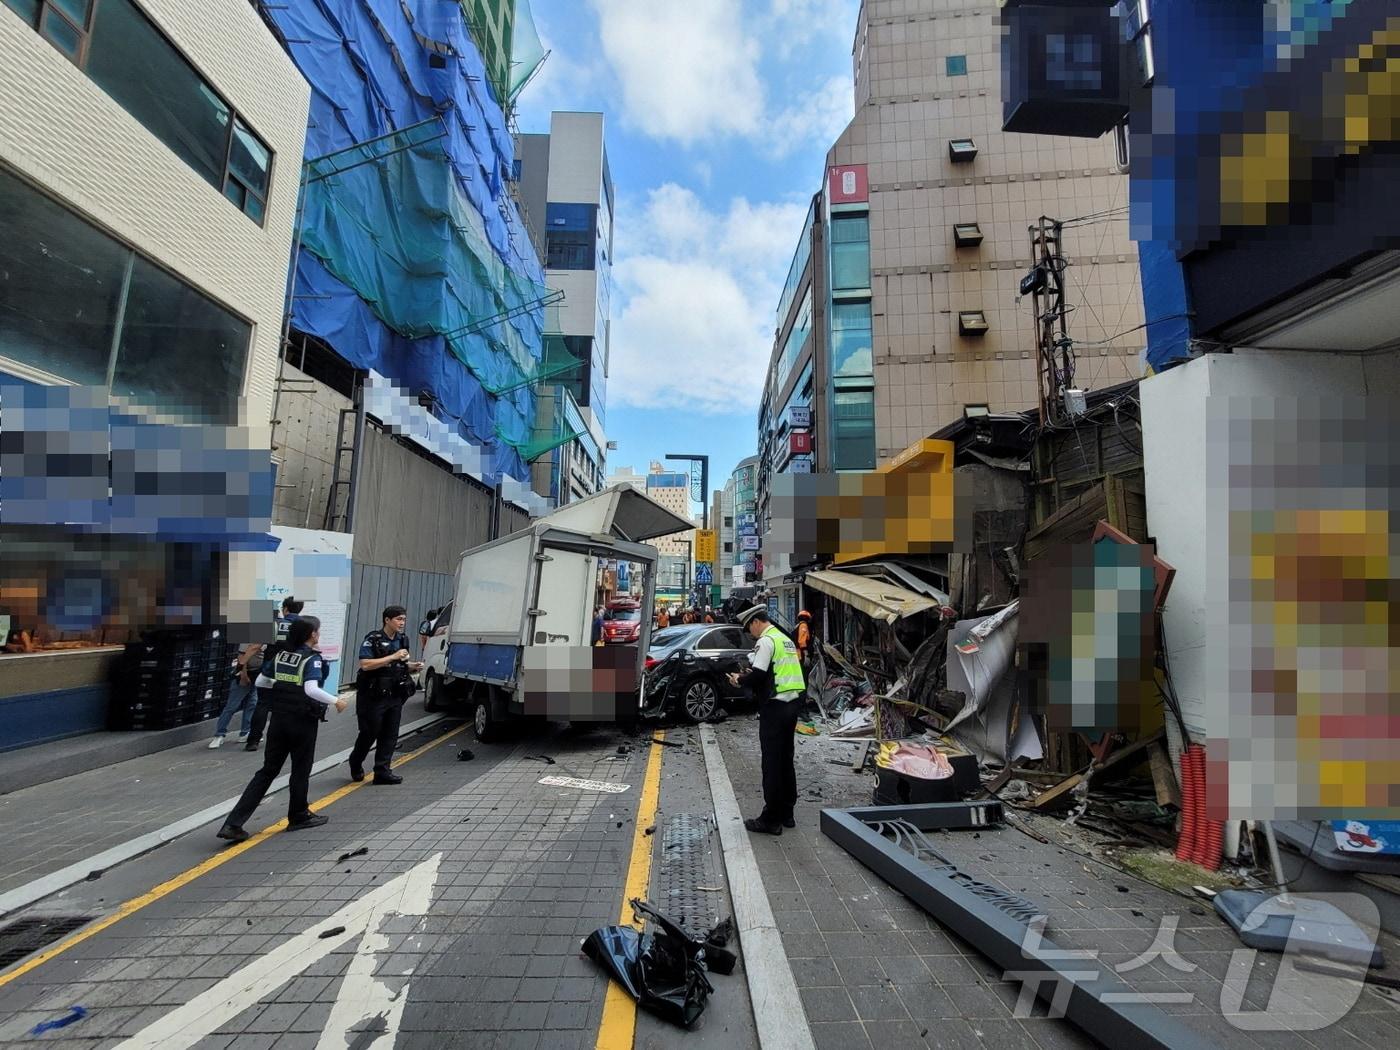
[118,854,442,1050]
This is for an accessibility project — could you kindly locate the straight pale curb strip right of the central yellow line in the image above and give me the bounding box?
[700,725,816,1050]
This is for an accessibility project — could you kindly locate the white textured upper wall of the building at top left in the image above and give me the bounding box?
[0,0,311,427]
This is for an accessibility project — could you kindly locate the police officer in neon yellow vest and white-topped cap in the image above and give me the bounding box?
[729,605,806,834]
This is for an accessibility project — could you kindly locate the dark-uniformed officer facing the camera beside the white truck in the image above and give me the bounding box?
[350,605,423,784]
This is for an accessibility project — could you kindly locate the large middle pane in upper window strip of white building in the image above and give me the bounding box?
[87,0,232,188]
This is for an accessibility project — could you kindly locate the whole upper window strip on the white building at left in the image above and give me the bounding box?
[0,0,273,224]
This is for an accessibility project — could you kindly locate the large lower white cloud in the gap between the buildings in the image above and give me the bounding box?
[608,183,808,413]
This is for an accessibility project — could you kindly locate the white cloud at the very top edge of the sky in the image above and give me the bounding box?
[592,0,764,146]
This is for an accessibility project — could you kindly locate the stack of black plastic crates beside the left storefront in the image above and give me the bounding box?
[109,627,231,729]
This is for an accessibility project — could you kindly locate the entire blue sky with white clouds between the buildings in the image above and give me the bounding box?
[517,0,860,509]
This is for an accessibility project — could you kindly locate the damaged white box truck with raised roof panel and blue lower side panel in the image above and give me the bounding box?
[423,484,694,741]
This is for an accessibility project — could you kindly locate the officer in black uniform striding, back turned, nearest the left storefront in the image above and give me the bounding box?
[218,616,349,843]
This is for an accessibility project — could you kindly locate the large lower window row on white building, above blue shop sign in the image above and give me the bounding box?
[0,168,252,424]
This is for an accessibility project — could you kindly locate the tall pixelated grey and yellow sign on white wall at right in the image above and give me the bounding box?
[1204,395,1400,820]
